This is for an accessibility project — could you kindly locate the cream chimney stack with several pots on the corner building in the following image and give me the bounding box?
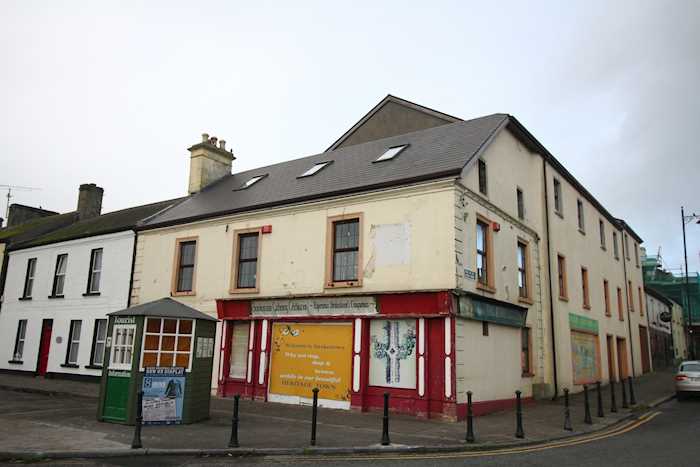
[188,133,235,194]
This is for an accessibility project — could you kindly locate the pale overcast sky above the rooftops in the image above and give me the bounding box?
[0,0,700,270]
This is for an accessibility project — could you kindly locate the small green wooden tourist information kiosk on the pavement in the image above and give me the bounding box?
[97,298,217,425]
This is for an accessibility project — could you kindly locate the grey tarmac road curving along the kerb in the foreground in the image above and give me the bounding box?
[16,400,700,467]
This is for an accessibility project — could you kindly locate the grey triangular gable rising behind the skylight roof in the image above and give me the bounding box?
[326,94,462,151]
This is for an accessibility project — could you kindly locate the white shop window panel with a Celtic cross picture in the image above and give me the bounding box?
[369,319,416,389]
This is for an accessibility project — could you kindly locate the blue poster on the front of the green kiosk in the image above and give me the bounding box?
[142,367,185,425]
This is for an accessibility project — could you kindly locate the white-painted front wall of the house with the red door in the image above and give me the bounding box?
[0,231,134,376]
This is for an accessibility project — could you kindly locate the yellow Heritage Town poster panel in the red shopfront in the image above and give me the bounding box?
[269,323,352,401]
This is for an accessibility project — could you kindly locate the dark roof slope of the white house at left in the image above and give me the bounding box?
[12,198,183,250]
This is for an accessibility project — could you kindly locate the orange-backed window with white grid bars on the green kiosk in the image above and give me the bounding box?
[141,318,194,369]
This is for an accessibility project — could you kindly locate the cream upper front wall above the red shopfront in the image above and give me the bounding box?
[132,181,455,392]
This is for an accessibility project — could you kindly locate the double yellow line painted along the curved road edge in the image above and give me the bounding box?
[274,412,661,462]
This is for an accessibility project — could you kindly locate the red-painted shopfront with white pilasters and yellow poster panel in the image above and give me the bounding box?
[217,292,456,417]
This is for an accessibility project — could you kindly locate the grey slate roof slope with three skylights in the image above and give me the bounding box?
[141,114,509,228]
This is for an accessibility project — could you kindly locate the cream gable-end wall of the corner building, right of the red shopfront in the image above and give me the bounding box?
[455,130,552,398]
